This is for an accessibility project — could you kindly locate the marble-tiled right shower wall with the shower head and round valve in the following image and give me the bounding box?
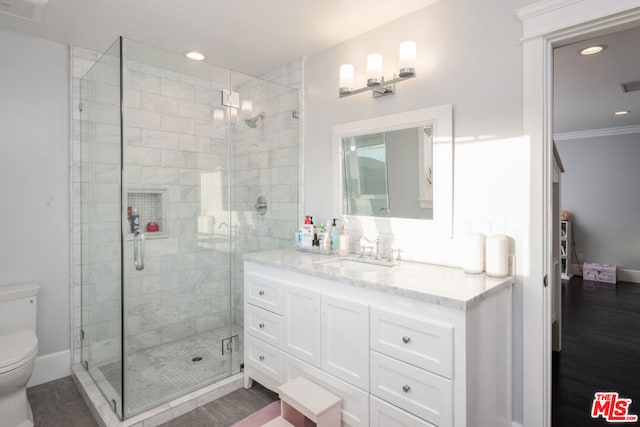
[231,59,304,327]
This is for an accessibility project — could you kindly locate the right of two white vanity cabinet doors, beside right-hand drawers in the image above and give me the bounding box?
[322,294,369,390]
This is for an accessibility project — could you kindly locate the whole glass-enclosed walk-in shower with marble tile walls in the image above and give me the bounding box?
[73,39,299,419]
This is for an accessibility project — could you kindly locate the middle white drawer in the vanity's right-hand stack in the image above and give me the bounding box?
[371,351,453,427]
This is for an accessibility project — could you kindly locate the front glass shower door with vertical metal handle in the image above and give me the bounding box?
[122,39,233,417]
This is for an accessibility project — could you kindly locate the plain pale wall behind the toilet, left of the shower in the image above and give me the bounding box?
[0,30,70,357]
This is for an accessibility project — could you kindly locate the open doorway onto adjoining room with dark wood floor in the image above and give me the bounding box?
[551,27,640,426]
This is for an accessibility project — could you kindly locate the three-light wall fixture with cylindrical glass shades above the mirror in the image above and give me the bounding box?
[338,41,416,98]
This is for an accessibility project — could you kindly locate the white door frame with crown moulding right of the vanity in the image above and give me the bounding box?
[517,0,640,427]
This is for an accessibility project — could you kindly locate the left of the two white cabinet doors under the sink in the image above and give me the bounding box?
[282,285,320,366]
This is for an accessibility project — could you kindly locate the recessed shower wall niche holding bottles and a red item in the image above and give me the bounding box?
[127,187,168,239]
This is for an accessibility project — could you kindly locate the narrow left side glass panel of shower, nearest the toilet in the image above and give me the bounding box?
[76,41,123,417]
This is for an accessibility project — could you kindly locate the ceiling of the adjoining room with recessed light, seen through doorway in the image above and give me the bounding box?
[553,27,640,134]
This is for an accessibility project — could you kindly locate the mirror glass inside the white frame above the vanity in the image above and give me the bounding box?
[341,125,433,219]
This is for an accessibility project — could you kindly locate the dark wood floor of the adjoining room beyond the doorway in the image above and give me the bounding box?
[552,276,640,427]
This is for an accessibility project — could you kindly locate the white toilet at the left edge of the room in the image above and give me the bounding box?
[0,283,40,427]
